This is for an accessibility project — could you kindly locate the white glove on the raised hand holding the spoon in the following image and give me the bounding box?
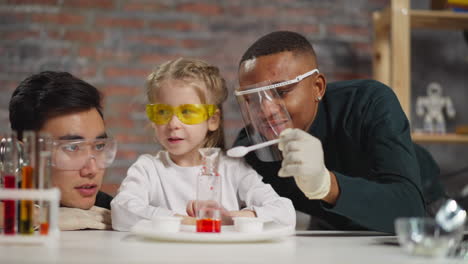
[278,128,330,199]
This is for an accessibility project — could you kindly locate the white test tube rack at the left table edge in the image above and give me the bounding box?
[0,188,60,245]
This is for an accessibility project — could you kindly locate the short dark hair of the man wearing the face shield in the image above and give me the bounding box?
[239,31,315,65]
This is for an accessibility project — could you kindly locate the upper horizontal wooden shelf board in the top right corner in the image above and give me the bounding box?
[410,10,468,29]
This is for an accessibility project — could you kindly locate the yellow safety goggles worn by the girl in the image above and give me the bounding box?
[146,104,218,125]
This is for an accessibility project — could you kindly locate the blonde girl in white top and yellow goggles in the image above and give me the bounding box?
[111,58,295,231]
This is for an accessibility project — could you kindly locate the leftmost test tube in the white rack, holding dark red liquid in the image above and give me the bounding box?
[2,132,18,235]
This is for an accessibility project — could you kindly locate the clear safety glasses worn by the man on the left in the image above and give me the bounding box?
[52,138,117,170]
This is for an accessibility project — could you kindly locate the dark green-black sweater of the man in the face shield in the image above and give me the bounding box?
[234,80,442,233]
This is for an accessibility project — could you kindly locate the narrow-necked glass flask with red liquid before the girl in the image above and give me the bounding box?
[195,148,222,233]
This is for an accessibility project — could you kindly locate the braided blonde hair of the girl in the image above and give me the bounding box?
[146,58,228,149]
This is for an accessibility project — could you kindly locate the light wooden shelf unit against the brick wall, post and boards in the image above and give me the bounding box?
[372,0,468,143]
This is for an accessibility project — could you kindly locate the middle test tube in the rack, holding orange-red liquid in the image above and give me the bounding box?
[18,131,36,234]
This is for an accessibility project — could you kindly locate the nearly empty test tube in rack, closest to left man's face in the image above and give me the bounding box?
[37,133,52,235]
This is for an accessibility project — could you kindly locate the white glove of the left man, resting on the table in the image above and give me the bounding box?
[59,206,112,230]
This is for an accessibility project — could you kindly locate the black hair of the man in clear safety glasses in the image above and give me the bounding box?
[9,71,103,133]
